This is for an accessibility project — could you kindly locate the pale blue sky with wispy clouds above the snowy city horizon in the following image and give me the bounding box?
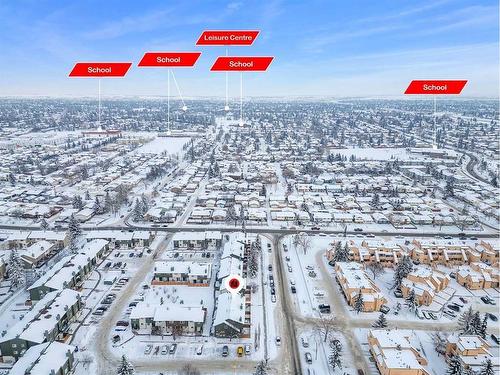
[0,0,499,96]
